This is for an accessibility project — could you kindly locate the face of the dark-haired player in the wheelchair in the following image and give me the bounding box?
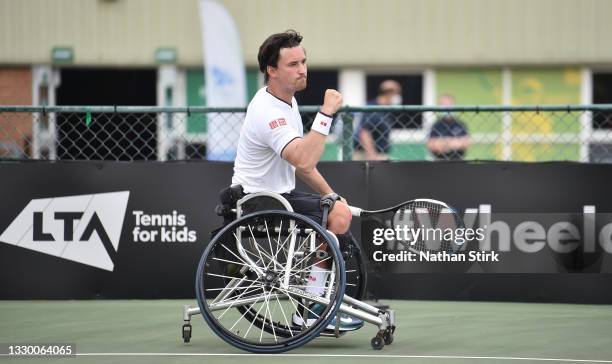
[270,46,307,92]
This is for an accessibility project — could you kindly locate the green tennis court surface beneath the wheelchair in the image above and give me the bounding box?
[0,300,612,364]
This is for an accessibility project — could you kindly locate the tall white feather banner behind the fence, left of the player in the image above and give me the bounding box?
[199,0,246,161]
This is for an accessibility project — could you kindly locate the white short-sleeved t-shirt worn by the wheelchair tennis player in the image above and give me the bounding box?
[232,87,304,193]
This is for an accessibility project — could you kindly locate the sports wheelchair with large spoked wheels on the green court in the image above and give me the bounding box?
[182,186,395,353]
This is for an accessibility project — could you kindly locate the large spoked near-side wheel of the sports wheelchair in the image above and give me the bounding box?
[196,210,346,353]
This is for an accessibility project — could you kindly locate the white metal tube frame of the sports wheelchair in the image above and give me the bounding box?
[182,192,395,351]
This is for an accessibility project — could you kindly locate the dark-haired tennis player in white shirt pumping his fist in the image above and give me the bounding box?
[218,30,363,331]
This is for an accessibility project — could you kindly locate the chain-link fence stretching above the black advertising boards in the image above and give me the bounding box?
[0,105,612,163]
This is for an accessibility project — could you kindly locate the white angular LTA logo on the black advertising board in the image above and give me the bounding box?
[0,191,130,271]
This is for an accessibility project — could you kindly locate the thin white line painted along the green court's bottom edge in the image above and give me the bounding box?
[65,353,612,363]
